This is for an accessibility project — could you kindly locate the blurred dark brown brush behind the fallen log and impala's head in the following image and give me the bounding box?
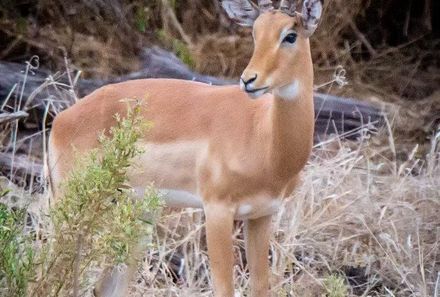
[0,0,440,141]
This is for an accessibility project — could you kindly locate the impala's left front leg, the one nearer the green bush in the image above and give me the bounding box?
[204,203,234,297]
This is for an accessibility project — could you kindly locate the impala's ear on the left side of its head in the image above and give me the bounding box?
[222,0,260,27]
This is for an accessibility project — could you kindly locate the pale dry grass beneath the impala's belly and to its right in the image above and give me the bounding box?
[124,131,440,297]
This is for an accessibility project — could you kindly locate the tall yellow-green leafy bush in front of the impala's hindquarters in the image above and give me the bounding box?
[31,100,160,296]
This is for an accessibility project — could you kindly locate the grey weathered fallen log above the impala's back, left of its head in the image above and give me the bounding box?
[0,47,234,112]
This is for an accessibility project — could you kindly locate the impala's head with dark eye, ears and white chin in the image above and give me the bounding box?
[222,0,322,100]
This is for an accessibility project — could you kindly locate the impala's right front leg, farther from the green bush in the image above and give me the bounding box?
[244,216,272,297]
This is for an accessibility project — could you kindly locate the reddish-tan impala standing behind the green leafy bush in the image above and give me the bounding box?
[48,0,322,297]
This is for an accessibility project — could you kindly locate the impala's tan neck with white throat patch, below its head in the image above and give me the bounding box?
[271,74,314,177]
